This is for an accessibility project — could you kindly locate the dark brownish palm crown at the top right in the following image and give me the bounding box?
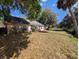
[57,0,77,10]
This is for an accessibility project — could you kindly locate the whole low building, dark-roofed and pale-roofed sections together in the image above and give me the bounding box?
[0,16,46,34]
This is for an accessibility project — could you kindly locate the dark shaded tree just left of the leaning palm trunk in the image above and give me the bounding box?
[60,15,74,31]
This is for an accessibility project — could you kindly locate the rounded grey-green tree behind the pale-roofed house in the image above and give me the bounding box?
[38,9,57,26]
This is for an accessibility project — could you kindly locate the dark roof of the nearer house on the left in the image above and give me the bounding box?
[5,16,30,24]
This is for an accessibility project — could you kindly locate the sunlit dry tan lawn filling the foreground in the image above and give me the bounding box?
[8,31,77,59]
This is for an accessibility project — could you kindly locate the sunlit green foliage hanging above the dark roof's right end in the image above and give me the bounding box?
[20,0,41,20]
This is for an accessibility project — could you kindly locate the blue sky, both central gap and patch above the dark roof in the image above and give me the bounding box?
[11,0,78,23]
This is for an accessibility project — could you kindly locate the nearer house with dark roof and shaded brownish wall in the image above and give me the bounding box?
[4,16,30,34]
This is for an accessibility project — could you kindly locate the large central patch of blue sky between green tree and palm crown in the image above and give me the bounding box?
[40,0,67,23]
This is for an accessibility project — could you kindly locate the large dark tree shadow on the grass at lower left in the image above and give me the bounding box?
[0,33,30,59]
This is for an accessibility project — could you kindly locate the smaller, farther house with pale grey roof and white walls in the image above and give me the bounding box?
[30,21,45,31]
